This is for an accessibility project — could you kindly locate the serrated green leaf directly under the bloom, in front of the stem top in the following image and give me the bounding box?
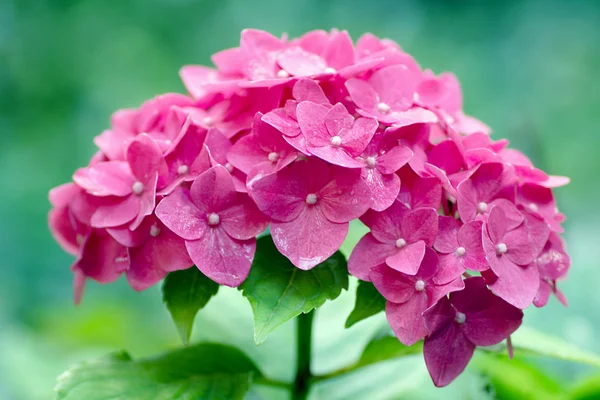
[240,236,348,344]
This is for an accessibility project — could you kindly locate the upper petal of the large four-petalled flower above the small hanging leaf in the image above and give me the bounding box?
[190,165,237,213]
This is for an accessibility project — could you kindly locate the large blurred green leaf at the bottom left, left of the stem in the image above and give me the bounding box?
[56,343,261,400]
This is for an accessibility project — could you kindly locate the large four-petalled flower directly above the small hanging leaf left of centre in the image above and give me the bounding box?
[156,166,267,287]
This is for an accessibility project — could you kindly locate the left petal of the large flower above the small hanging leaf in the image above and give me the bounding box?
[156,188,208,240]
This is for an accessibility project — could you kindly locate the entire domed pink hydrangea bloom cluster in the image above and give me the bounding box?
[49,29,570,386]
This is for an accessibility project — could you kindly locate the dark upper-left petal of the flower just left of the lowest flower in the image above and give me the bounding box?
[369,264,414,302]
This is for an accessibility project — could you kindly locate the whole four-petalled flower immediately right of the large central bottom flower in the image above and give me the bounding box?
[348,201,438,280]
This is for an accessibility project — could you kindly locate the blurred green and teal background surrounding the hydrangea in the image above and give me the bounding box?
[0,0,600,400]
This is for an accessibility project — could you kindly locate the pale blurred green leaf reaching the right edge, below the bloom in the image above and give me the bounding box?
[490,326,600,367]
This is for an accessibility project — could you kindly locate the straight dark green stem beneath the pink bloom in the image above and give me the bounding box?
[292,310,315,400]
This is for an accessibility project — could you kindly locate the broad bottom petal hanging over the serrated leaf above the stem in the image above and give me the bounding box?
[271,207,348,270]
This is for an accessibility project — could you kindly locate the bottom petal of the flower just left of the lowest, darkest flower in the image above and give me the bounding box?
[385,296,427,346]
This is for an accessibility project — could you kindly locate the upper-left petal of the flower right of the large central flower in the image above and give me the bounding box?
[361,201,409,244]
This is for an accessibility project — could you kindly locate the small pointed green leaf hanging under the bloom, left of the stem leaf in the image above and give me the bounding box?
[162,267,219,344]
